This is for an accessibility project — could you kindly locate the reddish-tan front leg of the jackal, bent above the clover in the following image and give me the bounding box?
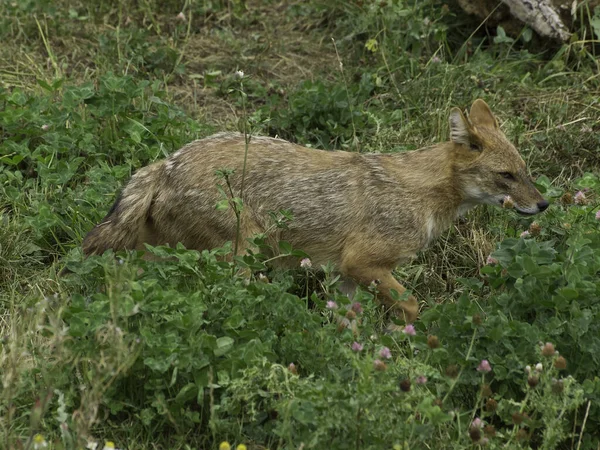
[344,267,419,323]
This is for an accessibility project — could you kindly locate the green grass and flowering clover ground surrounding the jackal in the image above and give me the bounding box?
[0,0,600,449]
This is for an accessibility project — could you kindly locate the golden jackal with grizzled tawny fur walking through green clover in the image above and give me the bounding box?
[83,100,548,322]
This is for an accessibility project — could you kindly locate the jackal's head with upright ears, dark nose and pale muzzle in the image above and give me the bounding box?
[450,99,548,214]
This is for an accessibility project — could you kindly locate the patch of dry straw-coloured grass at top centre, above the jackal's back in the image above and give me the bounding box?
[170,1,339,126]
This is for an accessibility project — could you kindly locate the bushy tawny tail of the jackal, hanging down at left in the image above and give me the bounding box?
[83,163,163,256]
